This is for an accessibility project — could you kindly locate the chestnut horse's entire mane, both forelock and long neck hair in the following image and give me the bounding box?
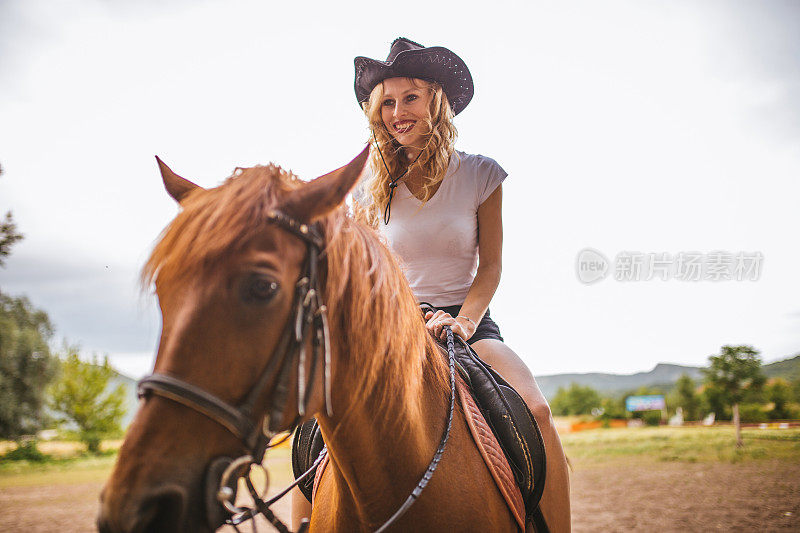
[142,165,449,428]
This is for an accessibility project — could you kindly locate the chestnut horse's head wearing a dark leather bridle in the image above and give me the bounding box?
[98,149,367,532]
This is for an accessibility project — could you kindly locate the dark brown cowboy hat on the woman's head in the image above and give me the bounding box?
[355,37,475,115]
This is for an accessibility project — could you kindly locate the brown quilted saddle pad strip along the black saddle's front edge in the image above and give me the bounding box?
[456,374,525,531]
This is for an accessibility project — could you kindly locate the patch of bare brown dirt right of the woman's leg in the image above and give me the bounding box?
[572,460,800,532]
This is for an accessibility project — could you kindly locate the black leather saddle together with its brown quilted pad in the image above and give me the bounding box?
[292,320,547,532]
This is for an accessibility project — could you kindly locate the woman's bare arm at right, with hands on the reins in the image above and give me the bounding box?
[425,185,503,339]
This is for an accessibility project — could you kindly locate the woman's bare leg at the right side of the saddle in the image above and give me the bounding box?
[472,339,571,533]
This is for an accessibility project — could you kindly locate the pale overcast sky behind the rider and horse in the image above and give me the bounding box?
[0,0,800,377]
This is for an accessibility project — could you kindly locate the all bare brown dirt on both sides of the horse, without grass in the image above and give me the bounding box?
[0,459,800,533]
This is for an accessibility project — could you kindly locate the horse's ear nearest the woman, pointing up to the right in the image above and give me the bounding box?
[282,146,369,222]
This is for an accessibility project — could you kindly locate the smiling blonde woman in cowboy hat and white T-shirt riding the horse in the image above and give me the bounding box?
[294,38,570,532]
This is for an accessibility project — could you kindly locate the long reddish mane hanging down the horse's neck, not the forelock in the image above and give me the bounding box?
[325,210,449,425]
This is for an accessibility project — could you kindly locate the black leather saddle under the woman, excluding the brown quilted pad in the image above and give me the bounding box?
[292,310,547,532]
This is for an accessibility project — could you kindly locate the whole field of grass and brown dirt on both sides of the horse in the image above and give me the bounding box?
[0,427,800,533]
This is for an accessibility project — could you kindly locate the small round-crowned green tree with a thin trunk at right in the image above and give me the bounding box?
[703,345,766,447]
